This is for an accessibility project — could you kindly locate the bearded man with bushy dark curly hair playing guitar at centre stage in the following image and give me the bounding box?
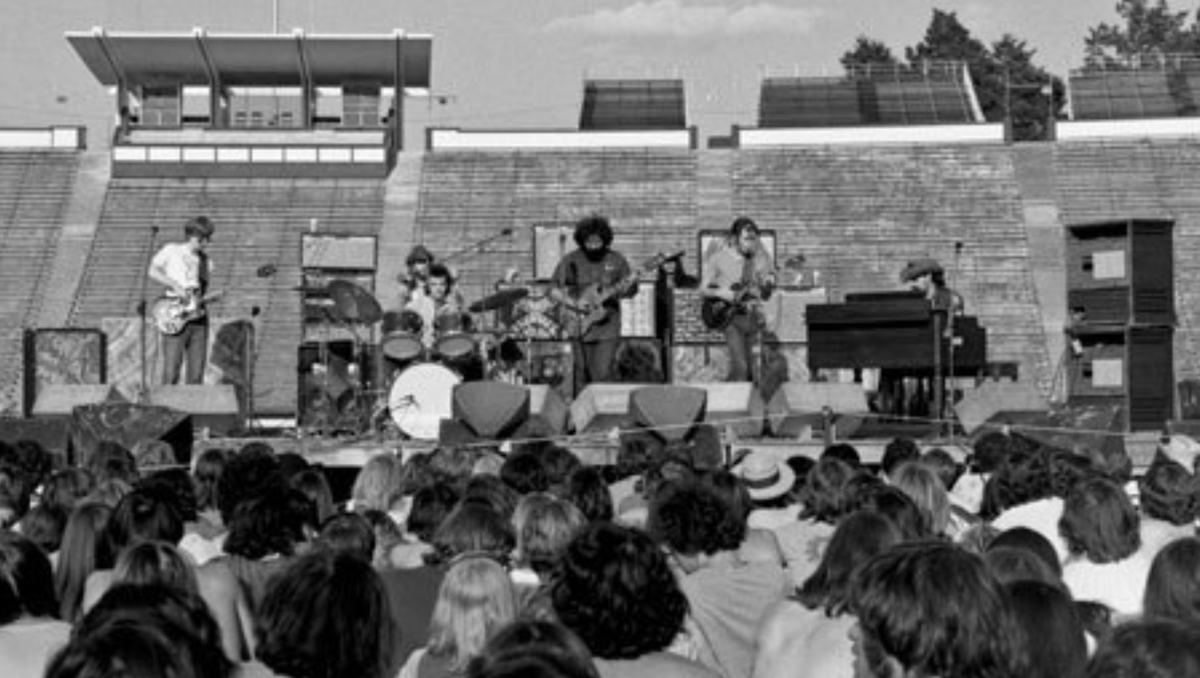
[551,215,637,392]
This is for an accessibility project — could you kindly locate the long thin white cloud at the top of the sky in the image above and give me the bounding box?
[546,0,821,40]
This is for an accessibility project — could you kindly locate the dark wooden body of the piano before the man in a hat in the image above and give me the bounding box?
[806,290,988,377]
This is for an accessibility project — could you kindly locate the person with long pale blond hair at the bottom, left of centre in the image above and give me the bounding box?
[400,552,518,678]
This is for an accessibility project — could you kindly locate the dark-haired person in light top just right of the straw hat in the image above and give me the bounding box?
[775,458,857,587]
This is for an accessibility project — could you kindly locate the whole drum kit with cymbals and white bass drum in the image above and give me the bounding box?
[312,280,573,440]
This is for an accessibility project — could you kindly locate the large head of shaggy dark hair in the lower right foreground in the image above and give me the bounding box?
[851,541,1028,678]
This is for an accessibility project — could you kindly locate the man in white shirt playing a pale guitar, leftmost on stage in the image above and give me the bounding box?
[149,216,215,384]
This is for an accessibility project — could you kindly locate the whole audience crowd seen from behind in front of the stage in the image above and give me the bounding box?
[0,432,1200,678]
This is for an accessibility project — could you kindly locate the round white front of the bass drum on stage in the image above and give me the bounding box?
[388,362,462,440]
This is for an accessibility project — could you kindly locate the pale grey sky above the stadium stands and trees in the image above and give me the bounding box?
[0,0,1123,145]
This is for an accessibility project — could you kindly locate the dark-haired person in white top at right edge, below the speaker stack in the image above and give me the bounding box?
[1138,454,1198,553]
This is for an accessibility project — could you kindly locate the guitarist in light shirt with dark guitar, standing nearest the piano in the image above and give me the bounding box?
[701,216,775,382]
